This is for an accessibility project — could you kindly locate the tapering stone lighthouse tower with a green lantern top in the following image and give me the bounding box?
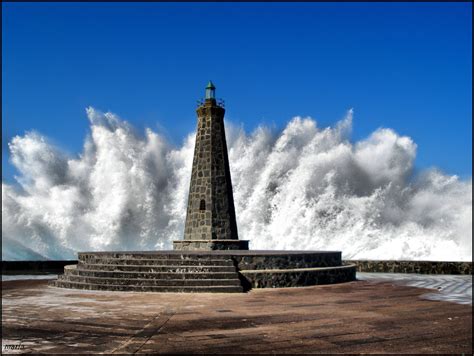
[173,81,248,251]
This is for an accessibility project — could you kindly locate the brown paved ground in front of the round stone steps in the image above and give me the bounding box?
[2,274,472,354]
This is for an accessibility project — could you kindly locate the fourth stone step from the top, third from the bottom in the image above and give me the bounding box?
[64,269,237,280]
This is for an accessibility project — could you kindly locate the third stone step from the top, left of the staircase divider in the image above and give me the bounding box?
[78,263,235,273]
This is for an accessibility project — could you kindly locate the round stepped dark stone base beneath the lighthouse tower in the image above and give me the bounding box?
[50,250,356,293]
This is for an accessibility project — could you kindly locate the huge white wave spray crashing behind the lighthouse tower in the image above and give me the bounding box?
[2,108,472,261]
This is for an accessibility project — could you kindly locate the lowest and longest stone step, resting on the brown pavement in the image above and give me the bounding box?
[50,280,243,293]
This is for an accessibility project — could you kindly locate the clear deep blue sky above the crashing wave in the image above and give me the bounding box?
[2,3,472,182]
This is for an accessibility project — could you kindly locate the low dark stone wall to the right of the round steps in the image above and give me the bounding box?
[344,260,472,274]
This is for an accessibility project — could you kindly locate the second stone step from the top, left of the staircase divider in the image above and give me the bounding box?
[79,258,234,266]
